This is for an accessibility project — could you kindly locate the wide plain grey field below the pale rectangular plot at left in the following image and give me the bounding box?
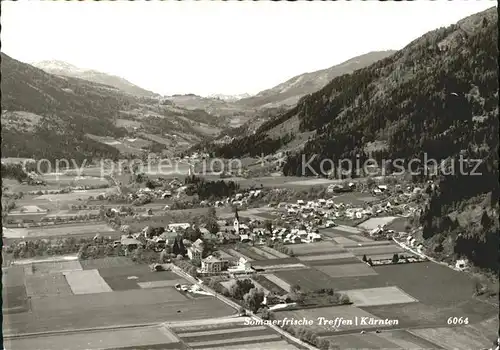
[4,288,234,334]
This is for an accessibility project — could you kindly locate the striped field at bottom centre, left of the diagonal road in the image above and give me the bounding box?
[172,319,297,350]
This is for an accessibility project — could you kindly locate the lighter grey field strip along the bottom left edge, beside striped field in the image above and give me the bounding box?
[5,326,183,350]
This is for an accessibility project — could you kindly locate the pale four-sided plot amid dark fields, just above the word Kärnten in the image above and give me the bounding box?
[341,287,417,307]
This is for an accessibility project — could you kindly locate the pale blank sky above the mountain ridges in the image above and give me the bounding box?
[1,0,496,95]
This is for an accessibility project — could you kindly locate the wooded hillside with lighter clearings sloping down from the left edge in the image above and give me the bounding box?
[1,53,229,164]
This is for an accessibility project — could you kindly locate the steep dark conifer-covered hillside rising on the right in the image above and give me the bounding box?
[212,8,499,272]
